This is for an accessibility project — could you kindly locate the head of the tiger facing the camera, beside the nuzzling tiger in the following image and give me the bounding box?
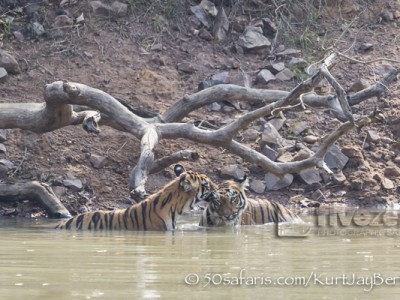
[200,176,248,226]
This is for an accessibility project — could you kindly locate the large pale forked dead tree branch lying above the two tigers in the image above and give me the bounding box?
[0,54,397,211]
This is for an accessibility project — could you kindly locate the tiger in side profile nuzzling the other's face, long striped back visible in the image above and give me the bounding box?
[56,164,213,231]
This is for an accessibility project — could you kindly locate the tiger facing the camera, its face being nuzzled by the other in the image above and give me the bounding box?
[199,176,303,227]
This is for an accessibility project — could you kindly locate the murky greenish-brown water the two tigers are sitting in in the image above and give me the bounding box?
[0,212,400,300]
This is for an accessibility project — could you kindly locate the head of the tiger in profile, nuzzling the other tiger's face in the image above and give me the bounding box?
[174,164,214,210]
